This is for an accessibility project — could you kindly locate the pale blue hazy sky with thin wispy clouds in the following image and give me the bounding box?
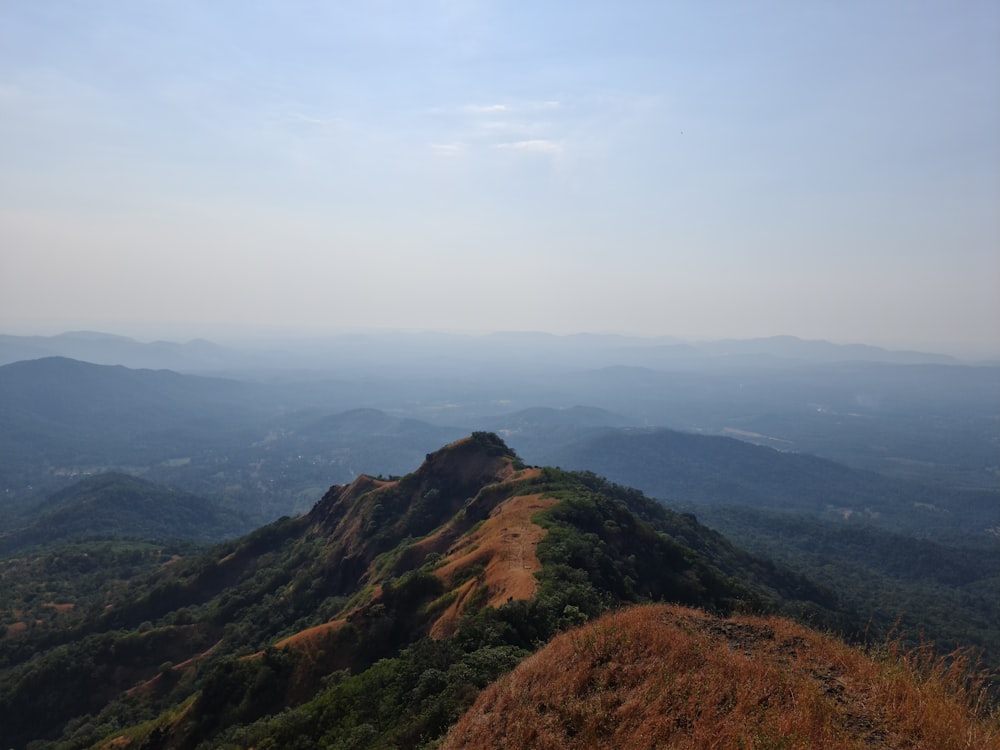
[0,0,1000,353]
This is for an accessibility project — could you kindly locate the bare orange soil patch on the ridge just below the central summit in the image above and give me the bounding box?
[431,494,557,638]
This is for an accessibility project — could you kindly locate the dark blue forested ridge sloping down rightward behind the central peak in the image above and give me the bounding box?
[508,428,1000,664]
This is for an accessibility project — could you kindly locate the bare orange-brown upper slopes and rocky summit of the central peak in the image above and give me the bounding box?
[260,446,540,652]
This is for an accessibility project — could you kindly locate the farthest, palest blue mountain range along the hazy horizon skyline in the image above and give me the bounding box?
[0,331,958,374]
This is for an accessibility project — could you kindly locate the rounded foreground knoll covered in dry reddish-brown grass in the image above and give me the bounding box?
[443,605,1000,750]
